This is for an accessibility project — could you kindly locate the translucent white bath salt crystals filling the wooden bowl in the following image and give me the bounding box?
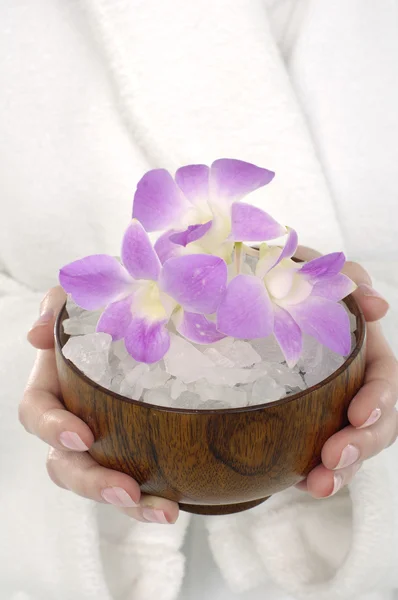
[63,299,356,410]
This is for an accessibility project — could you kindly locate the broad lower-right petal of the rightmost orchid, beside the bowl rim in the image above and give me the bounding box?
[285,296,351,356]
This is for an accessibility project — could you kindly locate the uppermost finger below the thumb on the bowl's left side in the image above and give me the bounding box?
[19,350,94,452]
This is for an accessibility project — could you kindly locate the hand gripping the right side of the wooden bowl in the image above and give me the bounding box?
[296,247,398,498]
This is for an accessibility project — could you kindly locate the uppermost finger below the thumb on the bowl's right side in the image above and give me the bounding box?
[348,323,398,427]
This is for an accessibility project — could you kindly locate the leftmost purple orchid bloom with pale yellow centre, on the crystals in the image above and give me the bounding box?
[59,219,227,363]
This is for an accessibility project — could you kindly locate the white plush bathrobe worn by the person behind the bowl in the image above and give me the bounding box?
[0,0,398,600]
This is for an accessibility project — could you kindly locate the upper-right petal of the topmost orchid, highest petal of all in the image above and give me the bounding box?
[210,158,275,204]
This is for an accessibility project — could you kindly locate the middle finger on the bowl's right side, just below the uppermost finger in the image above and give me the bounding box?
[322,408,398,470]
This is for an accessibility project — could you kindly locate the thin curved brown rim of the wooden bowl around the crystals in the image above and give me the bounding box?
[54,294,366,416]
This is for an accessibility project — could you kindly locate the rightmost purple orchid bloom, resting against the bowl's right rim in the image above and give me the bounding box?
[217,229,356,367]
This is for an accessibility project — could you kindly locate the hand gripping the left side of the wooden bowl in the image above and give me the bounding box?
[19,287,179,524]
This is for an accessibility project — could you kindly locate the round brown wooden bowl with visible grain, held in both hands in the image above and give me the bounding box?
[55,297,365,514]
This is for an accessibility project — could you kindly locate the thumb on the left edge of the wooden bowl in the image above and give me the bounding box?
[28,285,66,350]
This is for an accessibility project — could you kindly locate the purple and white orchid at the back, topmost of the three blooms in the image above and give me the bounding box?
[133,158,286,262]
